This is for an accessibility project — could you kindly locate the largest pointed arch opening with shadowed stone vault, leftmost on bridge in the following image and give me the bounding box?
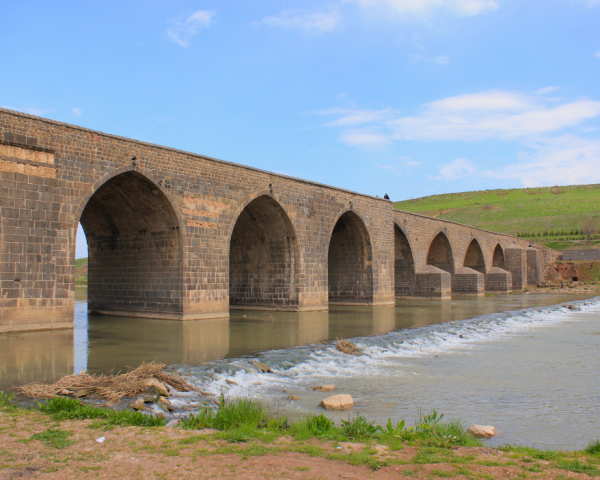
[80,171,183,318]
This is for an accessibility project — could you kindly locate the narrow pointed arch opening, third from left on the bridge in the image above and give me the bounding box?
[327,211,373,303]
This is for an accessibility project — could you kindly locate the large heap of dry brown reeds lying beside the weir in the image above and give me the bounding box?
[16,362,206,402]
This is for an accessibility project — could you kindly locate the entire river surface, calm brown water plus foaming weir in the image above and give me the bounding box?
[0,289,600,450]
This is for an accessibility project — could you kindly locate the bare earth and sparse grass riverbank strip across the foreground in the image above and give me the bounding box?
[0,403,600,479]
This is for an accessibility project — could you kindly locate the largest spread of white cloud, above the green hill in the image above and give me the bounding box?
[319,87,600,186]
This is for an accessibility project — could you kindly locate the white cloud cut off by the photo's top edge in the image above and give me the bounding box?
[350,0,498,16]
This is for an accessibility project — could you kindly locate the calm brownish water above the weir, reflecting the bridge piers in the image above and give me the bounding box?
[0,288,592,389]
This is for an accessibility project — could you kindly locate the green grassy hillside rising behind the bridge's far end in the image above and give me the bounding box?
[394,185,600,250]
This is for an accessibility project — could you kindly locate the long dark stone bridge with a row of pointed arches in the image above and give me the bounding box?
[0,109,557,332]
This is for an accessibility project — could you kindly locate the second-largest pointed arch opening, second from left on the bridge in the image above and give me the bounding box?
[229,195,298,308]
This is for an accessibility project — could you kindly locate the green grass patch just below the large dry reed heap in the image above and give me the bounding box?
[38,397,167,428]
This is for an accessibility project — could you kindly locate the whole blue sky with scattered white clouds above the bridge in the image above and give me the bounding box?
[0,0,600,212]
